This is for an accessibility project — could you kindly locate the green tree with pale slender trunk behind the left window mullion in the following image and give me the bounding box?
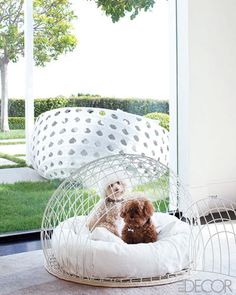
[0,0,77,131]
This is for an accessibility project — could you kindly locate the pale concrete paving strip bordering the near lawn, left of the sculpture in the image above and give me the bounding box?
[0,167,45,183]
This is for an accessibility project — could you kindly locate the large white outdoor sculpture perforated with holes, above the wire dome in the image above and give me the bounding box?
[31,108,169,179]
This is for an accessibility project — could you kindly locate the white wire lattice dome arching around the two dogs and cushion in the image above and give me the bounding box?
[41,154,191,286]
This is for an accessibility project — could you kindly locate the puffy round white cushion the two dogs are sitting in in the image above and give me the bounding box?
[52,213,189,278]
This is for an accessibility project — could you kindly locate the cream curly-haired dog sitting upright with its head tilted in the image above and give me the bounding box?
[87,181,125,236]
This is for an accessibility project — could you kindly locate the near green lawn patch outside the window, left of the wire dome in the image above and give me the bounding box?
[0,181,59,234]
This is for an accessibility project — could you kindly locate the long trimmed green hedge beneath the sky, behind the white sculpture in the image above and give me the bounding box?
[9,96,169,117]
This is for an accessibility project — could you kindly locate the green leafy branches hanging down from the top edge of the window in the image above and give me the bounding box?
[95,0,155,22]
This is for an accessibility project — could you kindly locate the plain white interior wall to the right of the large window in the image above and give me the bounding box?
[178,0,236,201]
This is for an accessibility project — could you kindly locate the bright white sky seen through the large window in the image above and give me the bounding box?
[9,0,169,99]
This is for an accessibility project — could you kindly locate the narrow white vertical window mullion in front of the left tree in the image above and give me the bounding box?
[24,0,34,165]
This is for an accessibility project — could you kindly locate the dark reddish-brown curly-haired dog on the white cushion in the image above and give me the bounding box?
[120,198,157,244]
